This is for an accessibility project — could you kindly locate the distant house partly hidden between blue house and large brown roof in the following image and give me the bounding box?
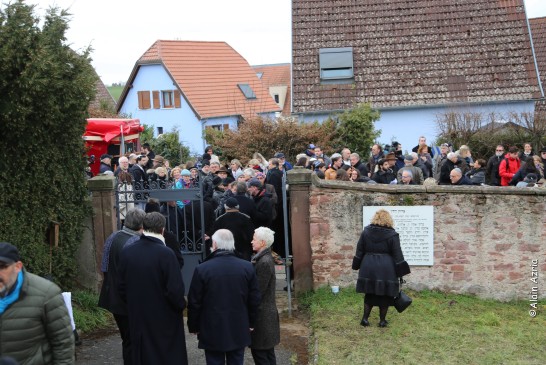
[252,63,291,117]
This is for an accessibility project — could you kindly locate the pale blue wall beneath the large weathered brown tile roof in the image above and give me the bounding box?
[299,101,535,152]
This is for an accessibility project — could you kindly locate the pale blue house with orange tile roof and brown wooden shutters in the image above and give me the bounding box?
[117,40,281,154]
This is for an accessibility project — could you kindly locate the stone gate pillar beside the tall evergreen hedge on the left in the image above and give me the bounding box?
[87,175,117,290]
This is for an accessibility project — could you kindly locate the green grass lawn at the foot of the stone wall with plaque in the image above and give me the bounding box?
[299,288,546,365]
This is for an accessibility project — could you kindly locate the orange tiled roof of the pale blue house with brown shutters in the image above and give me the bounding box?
[137,40,280,119]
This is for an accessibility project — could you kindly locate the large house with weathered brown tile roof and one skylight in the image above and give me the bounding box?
[292,0,544,150]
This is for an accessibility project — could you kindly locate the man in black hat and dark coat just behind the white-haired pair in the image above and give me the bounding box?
[211,198,254,261]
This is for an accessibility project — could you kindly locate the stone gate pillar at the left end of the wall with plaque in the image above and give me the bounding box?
[286,166,313,293]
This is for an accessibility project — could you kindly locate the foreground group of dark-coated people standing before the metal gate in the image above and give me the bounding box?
[99,208,280,365]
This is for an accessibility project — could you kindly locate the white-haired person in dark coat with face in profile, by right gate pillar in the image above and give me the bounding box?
[250,227,281,365]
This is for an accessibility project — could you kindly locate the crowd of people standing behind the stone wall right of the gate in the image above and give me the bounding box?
[296,137,546,187]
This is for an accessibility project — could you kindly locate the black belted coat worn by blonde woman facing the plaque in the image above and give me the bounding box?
[352,224,404,298]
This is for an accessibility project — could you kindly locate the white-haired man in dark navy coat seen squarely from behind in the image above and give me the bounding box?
[188,229,260,365]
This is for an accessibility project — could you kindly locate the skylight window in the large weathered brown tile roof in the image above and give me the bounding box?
[319,47,354,81]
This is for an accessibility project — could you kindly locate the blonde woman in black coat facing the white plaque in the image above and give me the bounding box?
[352,209,404,327]
